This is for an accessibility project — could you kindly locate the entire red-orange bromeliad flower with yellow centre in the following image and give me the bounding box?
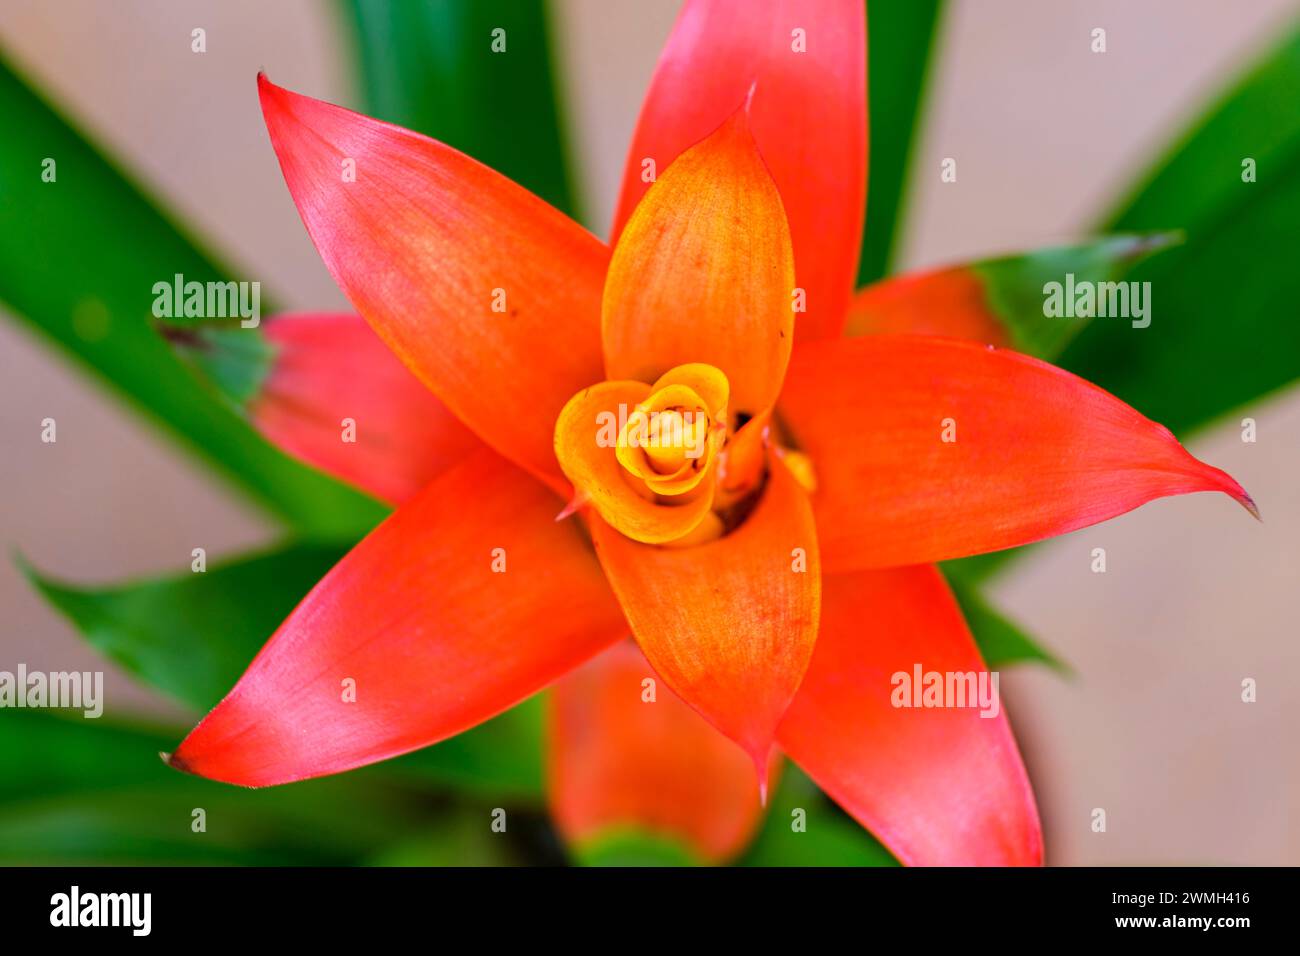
[162,0,1253,864]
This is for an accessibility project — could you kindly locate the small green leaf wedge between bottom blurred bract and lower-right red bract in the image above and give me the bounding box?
[740,763,898,866]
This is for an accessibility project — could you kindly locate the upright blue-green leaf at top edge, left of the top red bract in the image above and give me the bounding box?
[341,0,573,215]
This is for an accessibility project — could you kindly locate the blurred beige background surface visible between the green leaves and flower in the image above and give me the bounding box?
[0,0,1300,865]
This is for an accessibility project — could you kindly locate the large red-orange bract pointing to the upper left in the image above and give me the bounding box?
[257,77,608,492]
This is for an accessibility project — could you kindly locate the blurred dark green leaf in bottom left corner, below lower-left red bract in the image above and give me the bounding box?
[0,710,426,865]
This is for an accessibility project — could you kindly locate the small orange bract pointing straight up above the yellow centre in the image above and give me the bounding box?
[601,112,796,415]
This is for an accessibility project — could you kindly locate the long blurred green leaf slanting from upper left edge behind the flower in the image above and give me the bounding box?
[0,52,384,536]
